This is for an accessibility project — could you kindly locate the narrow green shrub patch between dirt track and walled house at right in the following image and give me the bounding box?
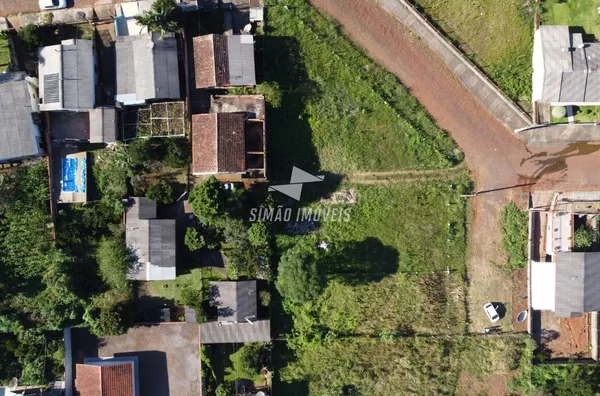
[500,202,529,269]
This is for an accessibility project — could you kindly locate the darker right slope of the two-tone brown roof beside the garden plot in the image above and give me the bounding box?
[217,113,246,172]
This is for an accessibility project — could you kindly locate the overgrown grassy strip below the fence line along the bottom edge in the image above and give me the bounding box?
[282,336,532,395]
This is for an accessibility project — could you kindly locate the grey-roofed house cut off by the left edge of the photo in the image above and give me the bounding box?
[0,72,45,162]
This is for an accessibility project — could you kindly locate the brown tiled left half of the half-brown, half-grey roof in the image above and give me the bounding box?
[193,34,229,88]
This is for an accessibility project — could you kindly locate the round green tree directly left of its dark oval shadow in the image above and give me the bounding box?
[275,249,322,304]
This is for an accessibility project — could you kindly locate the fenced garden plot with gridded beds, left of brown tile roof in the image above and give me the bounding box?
[122,102,186,141]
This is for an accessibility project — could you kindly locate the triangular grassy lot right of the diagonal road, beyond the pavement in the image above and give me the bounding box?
[416,0,533,106]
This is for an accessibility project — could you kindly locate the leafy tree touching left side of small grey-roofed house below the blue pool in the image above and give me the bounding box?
[96,236,133,289]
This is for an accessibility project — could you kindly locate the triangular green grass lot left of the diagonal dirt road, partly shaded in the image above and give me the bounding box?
[264,0,462,179]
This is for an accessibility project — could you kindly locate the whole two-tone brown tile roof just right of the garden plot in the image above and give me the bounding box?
[192,113,246,173]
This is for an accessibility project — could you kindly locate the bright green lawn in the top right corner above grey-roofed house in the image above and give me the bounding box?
[542,0,600,37]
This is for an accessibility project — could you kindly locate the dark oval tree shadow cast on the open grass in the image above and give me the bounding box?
[318,238,399,284]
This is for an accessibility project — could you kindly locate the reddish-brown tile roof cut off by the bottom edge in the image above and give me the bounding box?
[75,362,134,396]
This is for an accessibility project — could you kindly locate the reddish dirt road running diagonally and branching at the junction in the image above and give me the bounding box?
[310,0,600,352]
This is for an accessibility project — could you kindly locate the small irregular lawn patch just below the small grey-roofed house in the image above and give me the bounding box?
[147,268,225,301]
